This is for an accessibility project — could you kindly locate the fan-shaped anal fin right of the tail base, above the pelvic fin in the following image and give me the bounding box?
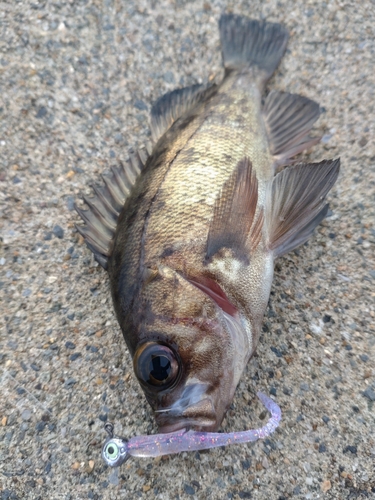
[263,90,320,166]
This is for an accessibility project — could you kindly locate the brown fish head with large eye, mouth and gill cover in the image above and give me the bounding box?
[133,270,249,432]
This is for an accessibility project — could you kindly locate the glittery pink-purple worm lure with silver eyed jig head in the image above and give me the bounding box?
[102,392,281,467]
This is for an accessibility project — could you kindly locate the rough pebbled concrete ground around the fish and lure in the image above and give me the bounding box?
[0,0,375,500]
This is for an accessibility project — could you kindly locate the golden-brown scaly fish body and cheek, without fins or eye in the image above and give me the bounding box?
[109,74,273,430]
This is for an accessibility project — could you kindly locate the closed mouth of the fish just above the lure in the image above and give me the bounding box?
[155,397,220,433]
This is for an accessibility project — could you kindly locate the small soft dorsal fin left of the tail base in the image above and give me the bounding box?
[150,84,216,142]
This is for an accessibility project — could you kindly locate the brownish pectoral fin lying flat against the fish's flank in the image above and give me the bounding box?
[206,157,263,260]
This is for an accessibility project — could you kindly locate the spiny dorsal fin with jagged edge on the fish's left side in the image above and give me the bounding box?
[75,148,149,269]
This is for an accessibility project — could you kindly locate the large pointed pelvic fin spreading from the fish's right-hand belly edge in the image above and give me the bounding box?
[265,159,340,257]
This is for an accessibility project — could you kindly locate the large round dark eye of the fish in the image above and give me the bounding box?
[133,342,180,391]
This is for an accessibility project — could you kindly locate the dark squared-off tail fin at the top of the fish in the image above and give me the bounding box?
[219,14,289,80]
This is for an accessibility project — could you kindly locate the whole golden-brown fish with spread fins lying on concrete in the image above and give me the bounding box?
[76,14,340,458]
